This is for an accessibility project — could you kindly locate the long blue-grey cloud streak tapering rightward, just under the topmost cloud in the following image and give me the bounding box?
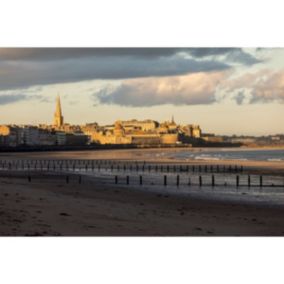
[0,56,230,90]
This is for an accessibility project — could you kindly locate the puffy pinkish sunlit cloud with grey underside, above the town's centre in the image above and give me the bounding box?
[95,72,228,107]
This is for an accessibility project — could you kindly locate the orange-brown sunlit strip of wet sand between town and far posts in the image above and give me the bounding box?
[0,147,284,176]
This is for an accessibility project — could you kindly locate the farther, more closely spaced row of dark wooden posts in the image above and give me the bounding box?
[0,160,244,173]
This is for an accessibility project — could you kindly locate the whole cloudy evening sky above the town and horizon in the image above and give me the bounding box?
[0,48,284,136]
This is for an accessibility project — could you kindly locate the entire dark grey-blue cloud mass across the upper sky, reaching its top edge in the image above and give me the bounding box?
[0,48,258,90]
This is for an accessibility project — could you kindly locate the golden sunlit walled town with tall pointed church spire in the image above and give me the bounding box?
[0,96,205,147]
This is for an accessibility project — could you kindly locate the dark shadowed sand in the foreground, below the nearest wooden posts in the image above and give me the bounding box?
[0,173,284,236]
